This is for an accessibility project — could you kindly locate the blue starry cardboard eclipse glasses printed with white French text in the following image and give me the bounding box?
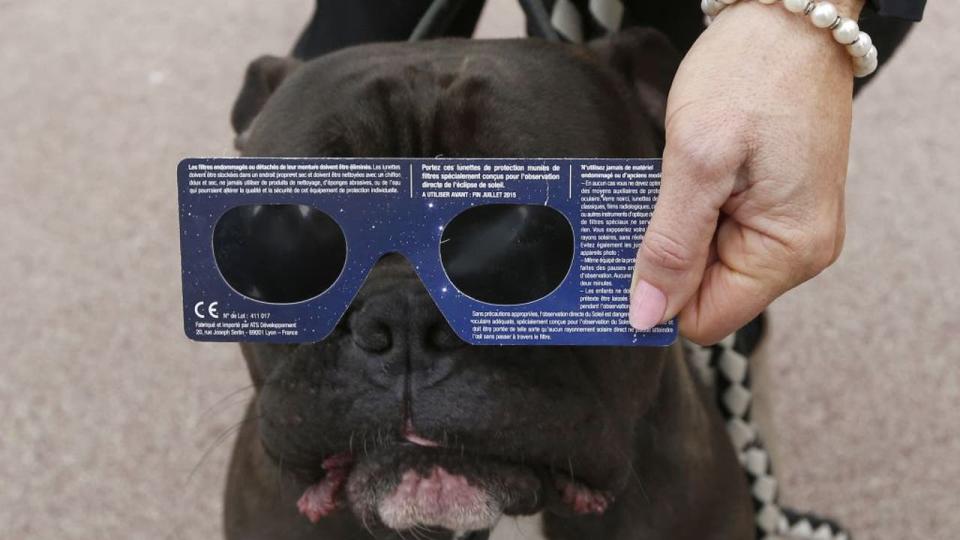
[178,158,676,345]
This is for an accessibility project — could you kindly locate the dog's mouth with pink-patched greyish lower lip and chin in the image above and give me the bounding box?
[286,430,613,532]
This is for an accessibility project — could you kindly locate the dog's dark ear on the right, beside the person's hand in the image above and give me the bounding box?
[589,27,681,140]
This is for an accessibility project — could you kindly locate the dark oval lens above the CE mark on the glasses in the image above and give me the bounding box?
[213,204,347,303]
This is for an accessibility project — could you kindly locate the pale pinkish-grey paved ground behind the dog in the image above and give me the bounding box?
[0,0,960,540]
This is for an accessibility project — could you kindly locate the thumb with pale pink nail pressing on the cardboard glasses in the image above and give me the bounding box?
[630,144,733,330]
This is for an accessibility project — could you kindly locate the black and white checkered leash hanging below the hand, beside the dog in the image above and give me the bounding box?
[684,318,852,540]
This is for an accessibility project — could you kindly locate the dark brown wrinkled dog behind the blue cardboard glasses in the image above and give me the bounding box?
[225,28,755,540]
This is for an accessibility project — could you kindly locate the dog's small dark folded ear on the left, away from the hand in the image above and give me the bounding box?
[230,55,302,149]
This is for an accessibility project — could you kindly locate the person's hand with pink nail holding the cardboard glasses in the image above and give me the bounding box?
[630,0,863,344]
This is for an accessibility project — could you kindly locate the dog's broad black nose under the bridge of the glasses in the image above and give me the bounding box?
[348,286,465,369]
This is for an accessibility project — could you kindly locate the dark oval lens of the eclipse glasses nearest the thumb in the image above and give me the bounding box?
[440,204,573,304]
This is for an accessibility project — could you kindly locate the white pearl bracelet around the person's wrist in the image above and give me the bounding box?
[700,0,879,77]
